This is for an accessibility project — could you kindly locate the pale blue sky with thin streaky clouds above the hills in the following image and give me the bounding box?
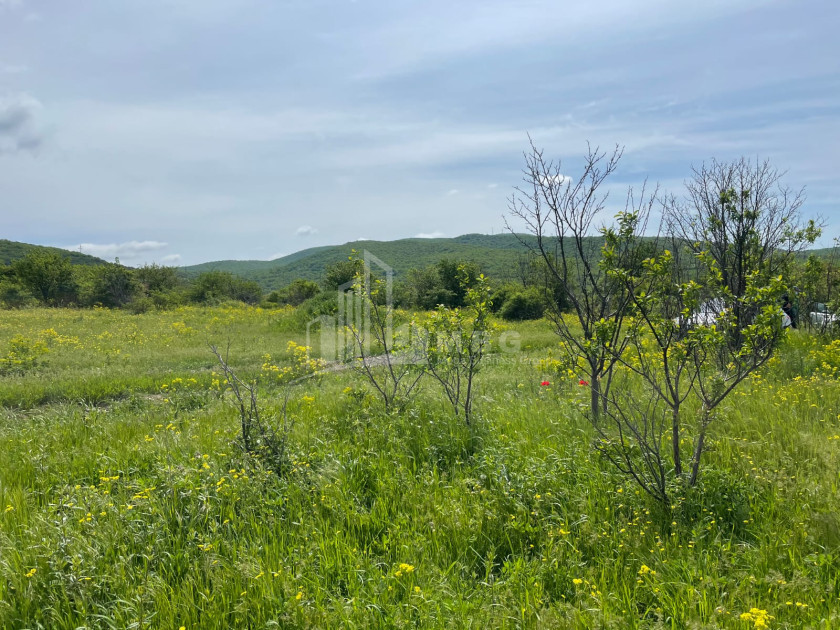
[0,0,840,265]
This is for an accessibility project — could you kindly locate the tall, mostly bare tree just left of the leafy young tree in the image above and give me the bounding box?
[508,138,651,422]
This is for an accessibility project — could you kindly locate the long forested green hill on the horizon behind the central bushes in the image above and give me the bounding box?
[182,234,544,290]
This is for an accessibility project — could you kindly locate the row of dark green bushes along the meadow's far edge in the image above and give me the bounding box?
[0,249,560,320]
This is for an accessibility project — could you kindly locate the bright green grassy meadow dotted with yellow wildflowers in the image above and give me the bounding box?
[0,305,840,630]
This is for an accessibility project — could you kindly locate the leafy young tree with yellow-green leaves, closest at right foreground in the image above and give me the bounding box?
[596,200,796,505]
